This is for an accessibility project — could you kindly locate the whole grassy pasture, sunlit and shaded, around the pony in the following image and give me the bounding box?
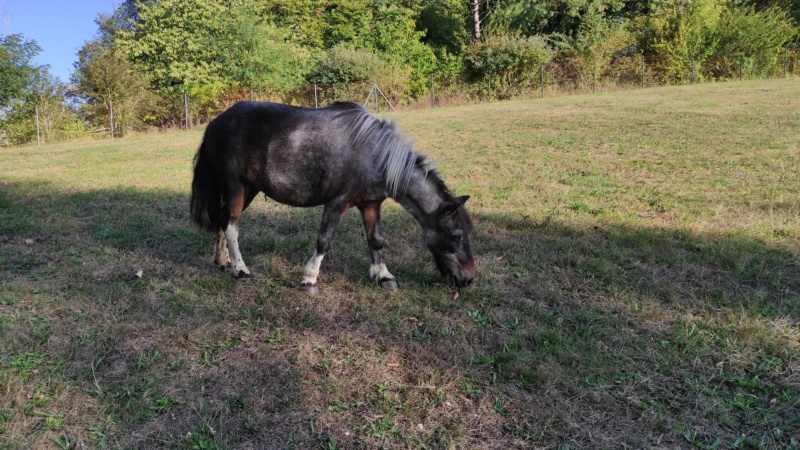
[0,80,800,449]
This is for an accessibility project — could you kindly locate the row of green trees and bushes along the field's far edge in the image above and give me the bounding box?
[0,0,800,144]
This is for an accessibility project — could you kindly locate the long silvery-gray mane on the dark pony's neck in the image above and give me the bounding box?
[335,103,438,197]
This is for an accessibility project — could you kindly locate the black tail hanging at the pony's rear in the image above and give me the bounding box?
[189,139,222,231]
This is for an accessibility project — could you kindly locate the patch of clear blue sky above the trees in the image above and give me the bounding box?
[0,0,121,82]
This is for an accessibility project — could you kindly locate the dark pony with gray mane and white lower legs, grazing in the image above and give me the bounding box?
[190,102,476,291]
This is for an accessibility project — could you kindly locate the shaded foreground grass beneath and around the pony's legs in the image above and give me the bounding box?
[0,183,800,448]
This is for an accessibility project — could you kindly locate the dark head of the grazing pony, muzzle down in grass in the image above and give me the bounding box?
[424,195,475,287]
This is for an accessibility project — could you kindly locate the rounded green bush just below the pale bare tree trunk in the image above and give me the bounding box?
[464,35,553,93]
